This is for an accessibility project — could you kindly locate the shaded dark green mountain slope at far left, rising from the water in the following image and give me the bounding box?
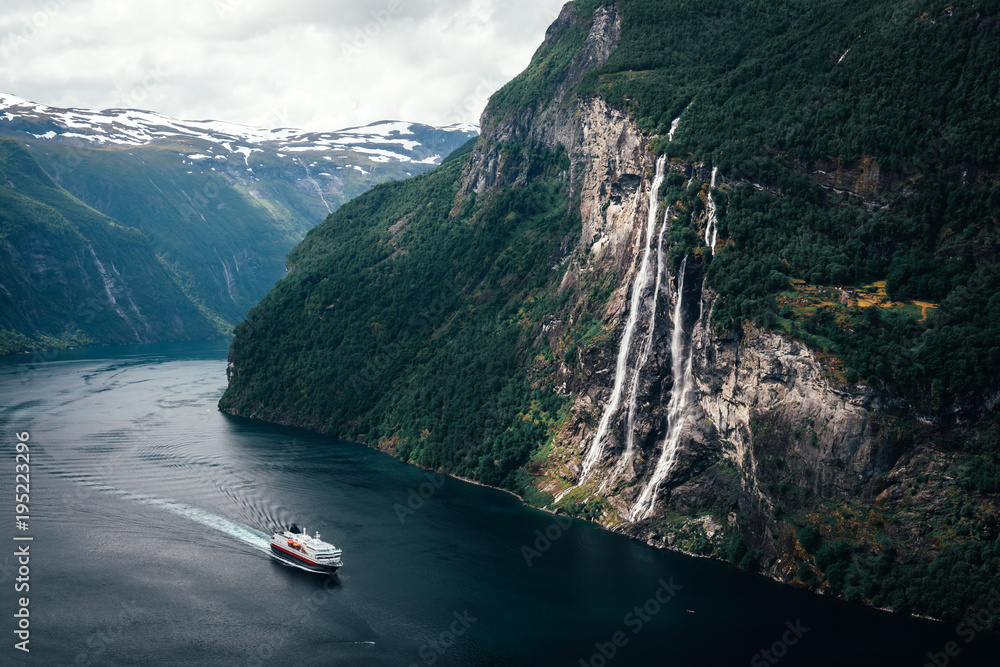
[0,139,220,353]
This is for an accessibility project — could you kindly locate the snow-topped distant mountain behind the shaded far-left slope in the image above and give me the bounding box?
[0,95,475,348]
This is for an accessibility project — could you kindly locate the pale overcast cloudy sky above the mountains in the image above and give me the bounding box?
[0,0,564,130]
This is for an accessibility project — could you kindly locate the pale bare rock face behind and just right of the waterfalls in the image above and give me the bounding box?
[508,105,898,535]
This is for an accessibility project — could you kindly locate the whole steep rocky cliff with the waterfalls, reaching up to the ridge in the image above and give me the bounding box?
[463,0,992,596]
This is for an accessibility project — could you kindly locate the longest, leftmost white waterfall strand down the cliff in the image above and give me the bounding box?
[576,156,667,488]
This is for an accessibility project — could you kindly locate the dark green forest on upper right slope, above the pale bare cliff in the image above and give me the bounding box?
[579,0,1000,398]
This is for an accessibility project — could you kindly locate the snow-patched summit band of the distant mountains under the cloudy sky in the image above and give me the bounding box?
[0,93,479,211]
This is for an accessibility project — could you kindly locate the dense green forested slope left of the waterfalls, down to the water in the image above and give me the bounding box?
[221,142,580,491]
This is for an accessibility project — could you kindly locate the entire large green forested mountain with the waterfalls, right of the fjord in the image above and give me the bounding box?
[220,0,1000,618]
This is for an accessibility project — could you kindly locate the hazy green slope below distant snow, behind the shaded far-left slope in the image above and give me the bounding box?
[31,143,300,326]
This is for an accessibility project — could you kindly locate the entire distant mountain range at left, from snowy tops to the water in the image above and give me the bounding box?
[0,94,478,353]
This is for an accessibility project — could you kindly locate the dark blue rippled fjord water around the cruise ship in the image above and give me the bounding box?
[0,342,1000,667]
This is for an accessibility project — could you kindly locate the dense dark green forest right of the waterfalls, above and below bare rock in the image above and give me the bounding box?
[578,0,1000,616]
